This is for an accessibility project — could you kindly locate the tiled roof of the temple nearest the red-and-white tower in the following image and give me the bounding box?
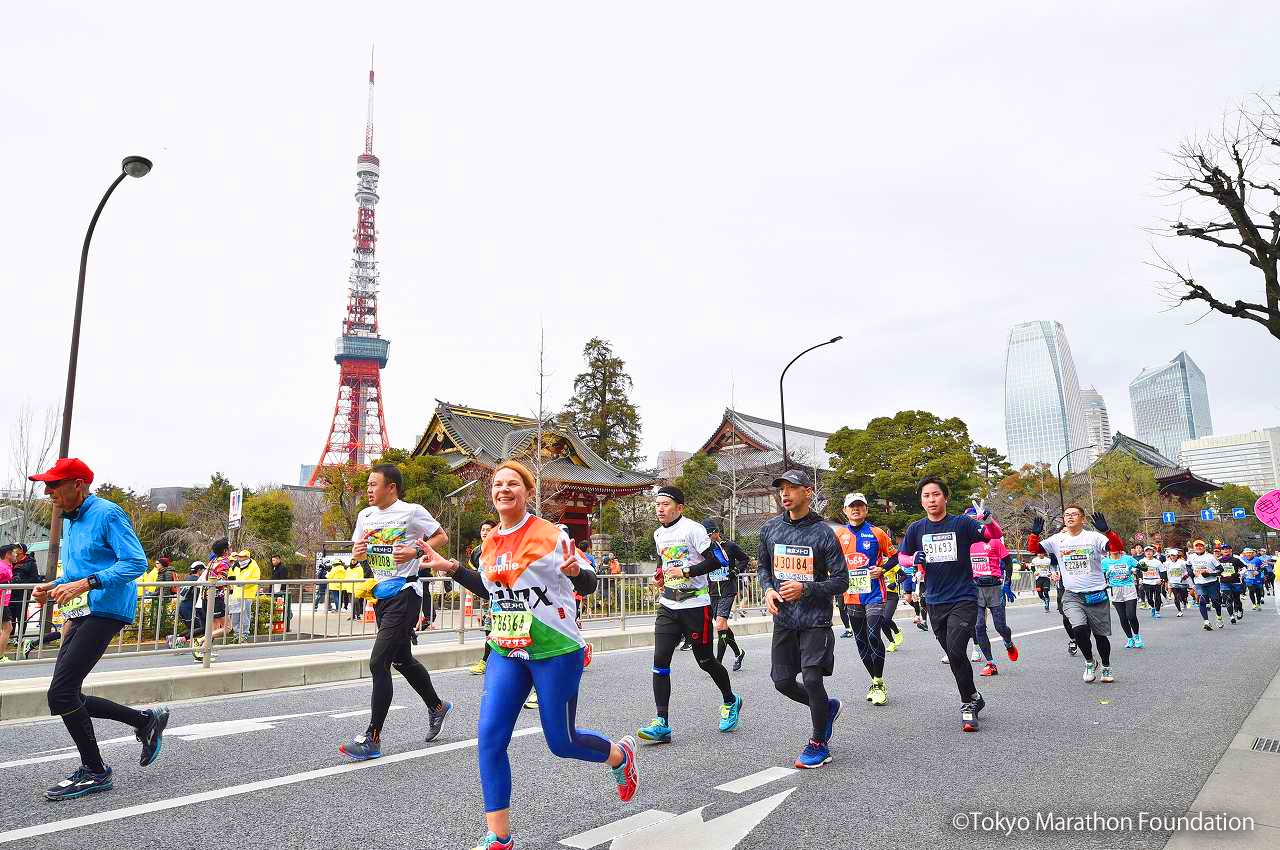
[413,399,657,493]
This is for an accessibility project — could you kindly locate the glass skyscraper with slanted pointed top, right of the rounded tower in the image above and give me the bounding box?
[1129,351,1213,461]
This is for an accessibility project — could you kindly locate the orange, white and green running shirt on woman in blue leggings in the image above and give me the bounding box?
[480,513,591,661]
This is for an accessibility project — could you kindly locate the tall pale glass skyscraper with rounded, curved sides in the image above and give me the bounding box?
[1005,321,1092,471]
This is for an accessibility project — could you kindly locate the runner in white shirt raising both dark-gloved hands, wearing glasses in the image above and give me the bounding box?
[1027,504,1124,682]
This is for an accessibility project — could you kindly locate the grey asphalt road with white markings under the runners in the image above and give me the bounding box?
[0,599,1280,850]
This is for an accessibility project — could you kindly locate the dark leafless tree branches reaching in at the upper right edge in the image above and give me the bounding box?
[1152,95,1280,339]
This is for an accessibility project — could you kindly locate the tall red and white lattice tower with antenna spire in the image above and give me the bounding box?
[308,59,390,484]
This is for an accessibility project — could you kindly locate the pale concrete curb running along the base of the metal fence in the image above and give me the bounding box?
[0,617,773,721]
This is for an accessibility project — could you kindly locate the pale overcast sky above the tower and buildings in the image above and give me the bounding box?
[0,0,1280,488]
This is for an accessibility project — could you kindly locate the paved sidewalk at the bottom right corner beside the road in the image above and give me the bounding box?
[1165,650,1280,850]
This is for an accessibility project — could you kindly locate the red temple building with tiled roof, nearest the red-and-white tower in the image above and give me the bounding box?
[413,401,657,541]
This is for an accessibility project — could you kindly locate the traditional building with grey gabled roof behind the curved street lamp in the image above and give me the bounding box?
[698,407,831,535]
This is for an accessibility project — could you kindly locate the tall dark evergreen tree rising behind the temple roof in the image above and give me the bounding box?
[559,337,644,470]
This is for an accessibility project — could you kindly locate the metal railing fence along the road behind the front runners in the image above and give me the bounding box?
[0,571,1049,667]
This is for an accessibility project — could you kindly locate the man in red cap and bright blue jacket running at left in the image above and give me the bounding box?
[31,457,169,800]
